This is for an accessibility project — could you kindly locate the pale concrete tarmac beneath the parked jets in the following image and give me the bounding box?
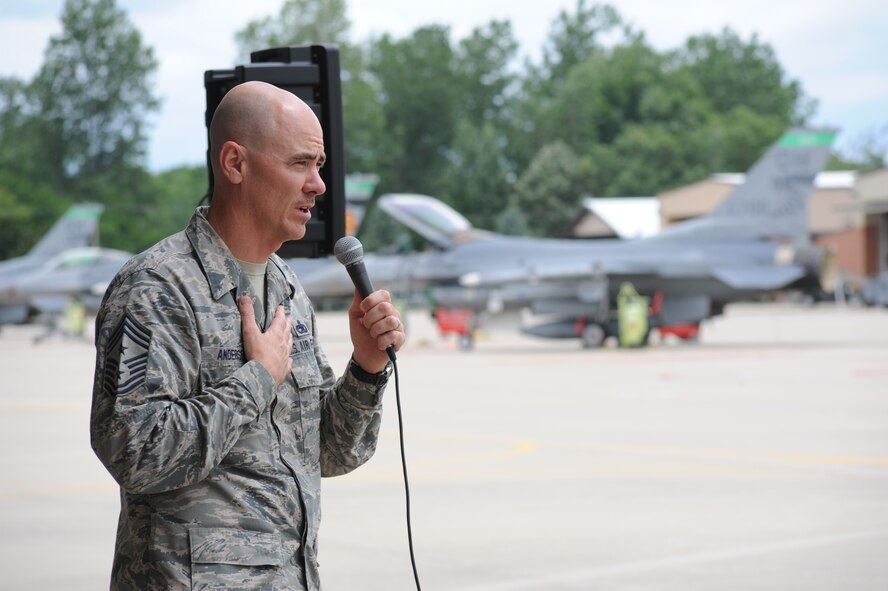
[0,305,888,591]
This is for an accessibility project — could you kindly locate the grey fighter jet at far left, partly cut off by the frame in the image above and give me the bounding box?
[0,203,132,325]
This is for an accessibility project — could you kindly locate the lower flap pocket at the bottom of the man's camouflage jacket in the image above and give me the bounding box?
[188,527,282,590]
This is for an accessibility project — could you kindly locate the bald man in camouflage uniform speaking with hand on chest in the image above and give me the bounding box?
[90,82,405,590]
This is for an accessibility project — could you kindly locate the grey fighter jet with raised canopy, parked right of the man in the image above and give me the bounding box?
[293,129,836,347]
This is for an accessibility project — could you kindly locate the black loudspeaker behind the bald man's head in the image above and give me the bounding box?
[204,45,345,258]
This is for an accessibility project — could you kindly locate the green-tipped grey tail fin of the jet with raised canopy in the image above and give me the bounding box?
[664,128,837,239]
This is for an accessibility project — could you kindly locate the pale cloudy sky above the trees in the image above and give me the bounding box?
[0,0,888,171]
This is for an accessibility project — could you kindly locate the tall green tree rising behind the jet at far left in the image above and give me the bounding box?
[18,0,160,249]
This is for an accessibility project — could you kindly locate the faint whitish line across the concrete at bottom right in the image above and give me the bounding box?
[459,529,888,591]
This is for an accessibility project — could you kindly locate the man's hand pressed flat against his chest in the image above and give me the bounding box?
[237,296,293,385]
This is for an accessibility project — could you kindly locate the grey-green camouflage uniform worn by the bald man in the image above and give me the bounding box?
[90,209,385,590]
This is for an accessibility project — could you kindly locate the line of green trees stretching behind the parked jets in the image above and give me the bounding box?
[0,0,885,259]
